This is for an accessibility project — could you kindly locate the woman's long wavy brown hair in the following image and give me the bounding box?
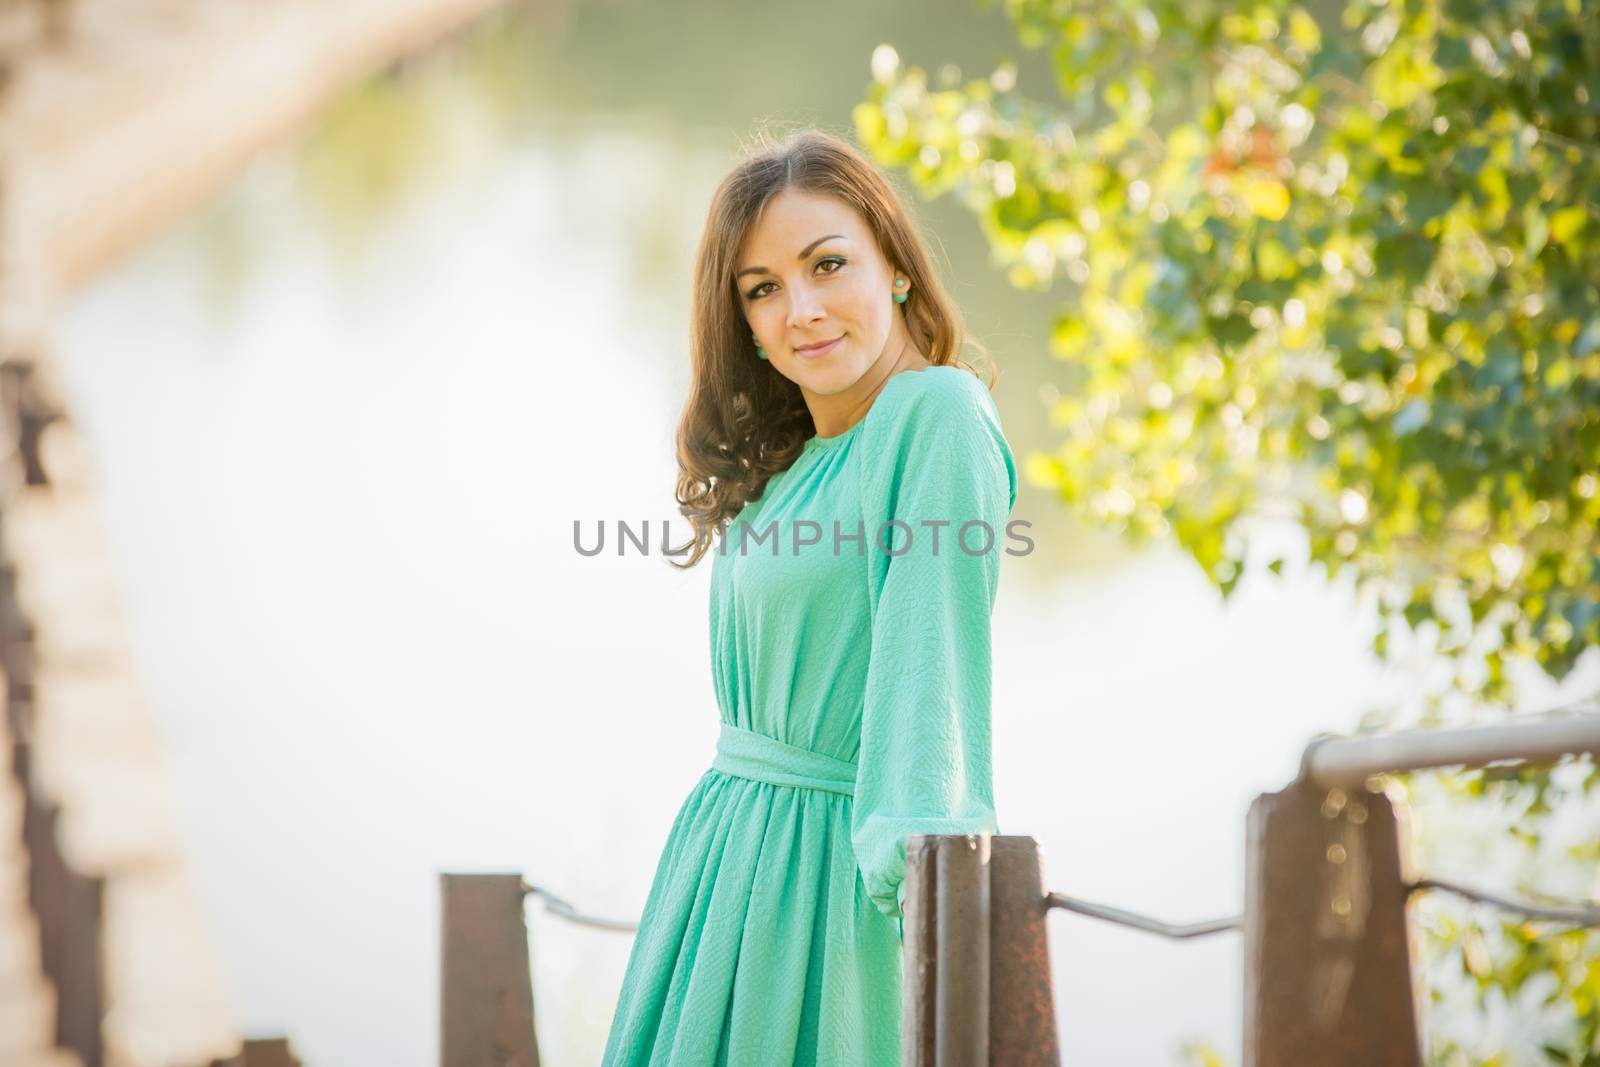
[669,128,994,569]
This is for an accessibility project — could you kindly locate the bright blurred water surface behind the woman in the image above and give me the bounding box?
[6,0,1576,1067]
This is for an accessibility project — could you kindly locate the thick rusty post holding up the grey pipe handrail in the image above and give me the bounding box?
[1243,779,1422,1067]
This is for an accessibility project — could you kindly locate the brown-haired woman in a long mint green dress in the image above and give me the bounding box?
[603,131,1016,1067]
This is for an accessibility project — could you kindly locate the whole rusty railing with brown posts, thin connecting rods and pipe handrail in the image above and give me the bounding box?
[442,713,1600,1067]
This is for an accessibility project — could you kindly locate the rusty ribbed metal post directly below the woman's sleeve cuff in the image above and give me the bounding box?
[901,833,1059,1067]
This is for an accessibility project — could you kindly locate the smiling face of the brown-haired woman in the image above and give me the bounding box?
[734,189,910,395]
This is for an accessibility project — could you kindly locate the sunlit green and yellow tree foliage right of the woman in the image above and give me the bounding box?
[854,0,1600,1064]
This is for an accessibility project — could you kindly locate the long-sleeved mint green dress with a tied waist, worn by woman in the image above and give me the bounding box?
[602,366,1016,1067]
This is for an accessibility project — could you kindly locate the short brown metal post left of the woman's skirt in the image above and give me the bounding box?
[440,875,539,1067]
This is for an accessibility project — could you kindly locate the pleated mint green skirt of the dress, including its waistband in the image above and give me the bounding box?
[602,723,901,1067]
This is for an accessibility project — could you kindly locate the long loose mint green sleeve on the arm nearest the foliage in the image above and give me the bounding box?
[851,368,1016,918]
